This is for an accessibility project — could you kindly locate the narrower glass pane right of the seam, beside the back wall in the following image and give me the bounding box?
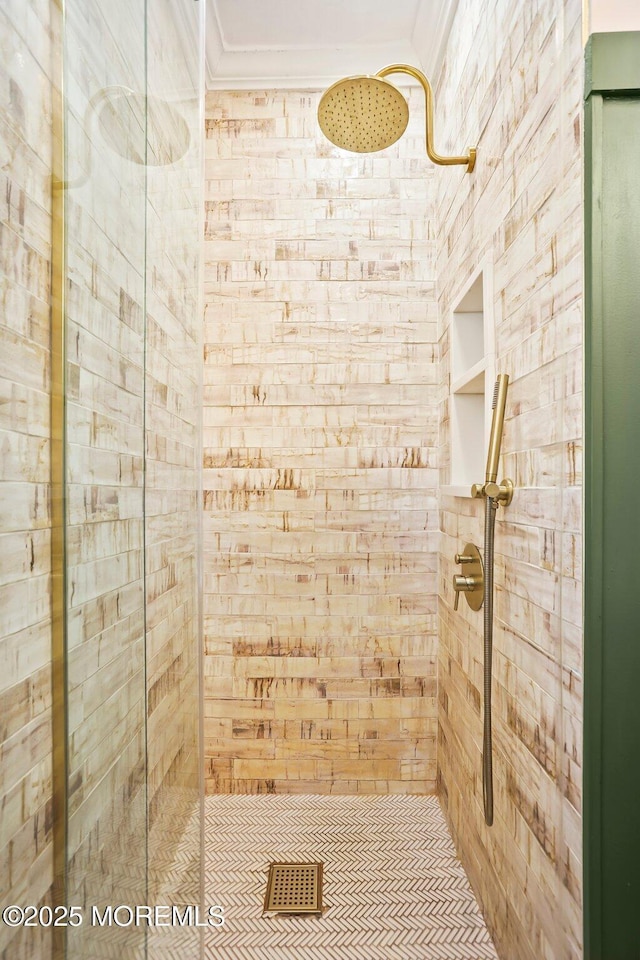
[145,0,203,960]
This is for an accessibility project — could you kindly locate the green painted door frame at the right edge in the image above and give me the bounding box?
[584,33,640,960]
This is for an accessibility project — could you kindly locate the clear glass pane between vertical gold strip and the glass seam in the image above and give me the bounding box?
[64,0,147,960]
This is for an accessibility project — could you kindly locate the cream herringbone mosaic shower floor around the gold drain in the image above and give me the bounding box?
[205,795,497,960]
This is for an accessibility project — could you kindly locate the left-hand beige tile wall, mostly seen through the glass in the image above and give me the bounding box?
[0,0,201,960]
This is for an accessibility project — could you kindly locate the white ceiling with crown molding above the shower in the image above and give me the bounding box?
[206,0,457,89]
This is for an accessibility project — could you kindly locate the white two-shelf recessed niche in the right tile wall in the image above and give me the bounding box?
[444,262,495,497]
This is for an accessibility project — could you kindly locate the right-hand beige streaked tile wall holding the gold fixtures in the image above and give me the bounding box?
[436,0,583,960]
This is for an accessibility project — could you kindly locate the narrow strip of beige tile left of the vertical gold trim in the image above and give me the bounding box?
[0,0,54,960]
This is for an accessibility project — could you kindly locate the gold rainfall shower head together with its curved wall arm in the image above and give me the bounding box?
[318,63,476,173]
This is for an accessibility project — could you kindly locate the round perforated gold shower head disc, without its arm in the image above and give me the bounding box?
[318,77,409,153]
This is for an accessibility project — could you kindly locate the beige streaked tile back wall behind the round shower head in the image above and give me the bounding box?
[204,90,438,793]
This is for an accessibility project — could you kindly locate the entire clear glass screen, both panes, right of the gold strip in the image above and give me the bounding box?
[64,0,203,960]
